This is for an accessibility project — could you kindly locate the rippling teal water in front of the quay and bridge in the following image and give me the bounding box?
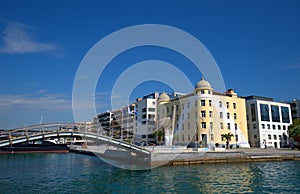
[0,153,300,193]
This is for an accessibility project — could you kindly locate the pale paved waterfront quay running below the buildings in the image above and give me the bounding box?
[71,146,300,167]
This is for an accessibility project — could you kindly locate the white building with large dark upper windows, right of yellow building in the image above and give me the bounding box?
[245,96,292,148]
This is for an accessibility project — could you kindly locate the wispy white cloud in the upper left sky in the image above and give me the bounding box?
[0,22,58,54]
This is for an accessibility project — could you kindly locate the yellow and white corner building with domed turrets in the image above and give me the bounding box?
[157,78,250,148]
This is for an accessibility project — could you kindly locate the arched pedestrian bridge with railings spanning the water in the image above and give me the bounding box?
[0,123,151,155]
